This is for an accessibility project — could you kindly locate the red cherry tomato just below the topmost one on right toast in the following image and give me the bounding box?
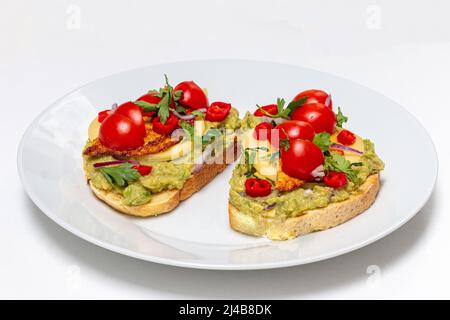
[291,103,336,134]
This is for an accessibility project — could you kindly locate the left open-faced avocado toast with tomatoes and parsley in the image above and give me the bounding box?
[83,77,240,216]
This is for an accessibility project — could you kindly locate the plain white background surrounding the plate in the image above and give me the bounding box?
[0,0,450,299]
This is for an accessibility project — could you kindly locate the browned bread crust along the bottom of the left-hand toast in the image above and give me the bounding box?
[85,140,238,217]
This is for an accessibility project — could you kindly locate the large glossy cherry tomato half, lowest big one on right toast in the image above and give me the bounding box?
[281,139,325,181]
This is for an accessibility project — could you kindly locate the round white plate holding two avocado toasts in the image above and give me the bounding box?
[18,60,438,269]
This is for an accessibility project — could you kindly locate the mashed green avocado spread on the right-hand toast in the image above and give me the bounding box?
[230,138,384,219]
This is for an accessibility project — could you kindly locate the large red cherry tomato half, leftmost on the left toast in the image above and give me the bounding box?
[99,113,144,151]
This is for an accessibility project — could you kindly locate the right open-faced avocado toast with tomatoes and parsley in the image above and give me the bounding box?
[229,90,384,240]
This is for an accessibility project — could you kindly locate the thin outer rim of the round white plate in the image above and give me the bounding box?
[16,59,439,270]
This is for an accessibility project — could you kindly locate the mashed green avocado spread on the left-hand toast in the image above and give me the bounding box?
[84,108,241,206]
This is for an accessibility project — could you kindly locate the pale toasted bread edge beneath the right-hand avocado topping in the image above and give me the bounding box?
[228,174,380,240]
